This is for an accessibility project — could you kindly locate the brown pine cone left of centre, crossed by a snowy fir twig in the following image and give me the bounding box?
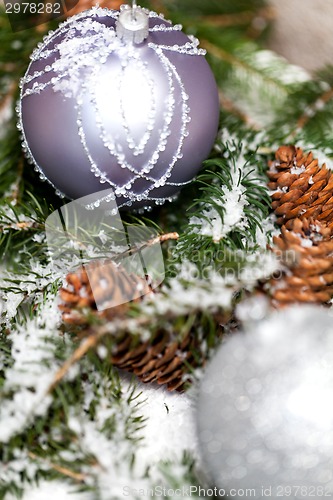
[59,262,218,391]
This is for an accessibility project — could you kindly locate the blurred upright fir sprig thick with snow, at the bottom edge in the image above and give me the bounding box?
[63,373,149,500]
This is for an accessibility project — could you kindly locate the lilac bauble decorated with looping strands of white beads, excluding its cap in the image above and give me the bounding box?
[18,7,219,208]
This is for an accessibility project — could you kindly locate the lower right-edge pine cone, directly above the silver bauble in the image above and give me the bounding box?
[268,218,333,307]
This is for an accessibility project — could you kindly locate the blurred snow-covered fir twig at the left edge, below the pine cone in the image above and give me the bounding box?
[0,300,60,443]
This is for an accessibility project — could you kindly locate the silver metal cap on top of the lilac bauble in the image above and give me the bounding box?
[116,0,149,45]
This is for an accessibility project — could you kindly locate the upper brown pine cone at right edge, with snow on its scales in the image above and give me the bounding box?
[267,146,333,229]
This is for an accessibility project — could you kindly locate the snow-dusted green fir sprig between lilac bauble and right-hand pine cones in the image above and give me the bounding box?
[177,137,270,258]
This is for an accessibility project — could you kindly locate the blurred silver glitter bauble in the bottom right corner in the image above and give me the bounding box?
[198,306,333,500]
